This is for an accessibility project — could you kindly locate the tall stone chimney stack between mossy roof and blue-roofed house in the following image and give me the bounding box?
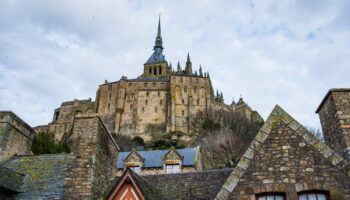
[63,117,119,200]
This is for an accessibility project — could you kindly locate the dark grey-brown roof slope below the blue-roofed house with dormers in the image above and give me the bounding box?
[141,169,232,200]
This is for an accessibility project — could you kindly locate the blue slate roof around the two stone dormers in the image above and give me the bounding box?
[118,148,197,169]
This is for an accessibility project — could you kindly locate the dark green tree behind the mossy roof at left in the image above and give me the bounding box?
[31,133,70,154]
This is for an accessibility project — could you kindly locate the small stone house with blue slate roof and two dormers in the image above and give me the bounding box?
[117,147,202,175]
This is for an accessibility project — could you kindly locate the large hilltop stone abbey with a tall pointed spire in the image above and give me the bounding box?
[35,19,262,140]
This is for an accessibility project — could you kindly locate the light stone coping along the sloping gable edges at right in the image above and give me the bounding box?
[215,105,350,199]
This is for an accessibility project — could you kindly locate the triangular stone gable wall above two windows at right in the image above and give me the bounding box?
[230,122,350,200]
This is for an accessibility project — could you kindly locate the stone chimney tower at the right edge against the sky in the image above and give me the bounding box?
[316,88,350,160]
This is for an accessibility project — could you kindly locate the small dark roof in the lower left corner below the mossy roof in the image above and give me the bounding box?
[0,165,25,192]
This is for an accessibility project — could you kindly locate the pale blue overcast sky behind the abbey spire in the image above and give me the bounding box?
[0,0,350,128]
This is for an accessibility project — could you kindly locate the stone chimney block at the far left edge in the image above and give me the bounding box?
[0,111,35,161]
